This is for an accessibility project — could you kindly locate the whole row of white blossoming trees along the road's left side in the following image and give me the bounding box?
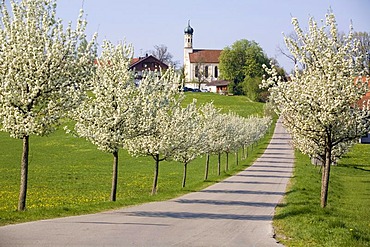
[0,0,271,211]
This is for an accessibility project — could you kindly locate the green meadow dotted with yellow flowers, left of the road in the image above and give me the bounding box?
[0,93,273,225]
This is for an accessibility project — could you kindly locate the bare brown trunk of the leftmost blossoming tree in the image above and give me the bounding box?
[18,136,30,211]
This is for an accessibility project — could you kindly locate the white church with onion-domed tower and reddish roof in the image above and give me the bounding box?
[184,21,222,89]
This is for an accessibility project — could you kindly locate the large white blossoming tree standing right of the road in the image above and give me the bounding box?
[264,12,370,207]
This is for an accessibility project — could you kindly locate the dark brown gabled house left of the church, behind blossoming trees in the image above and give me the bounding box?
[130,54,168,80]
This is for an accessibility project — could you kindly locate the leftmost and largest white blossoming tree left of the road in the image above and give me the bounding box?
[0,0,95,211]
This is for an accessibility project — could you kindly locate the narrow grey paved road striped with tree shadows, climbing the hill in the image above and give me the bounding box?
[0,118,294,247]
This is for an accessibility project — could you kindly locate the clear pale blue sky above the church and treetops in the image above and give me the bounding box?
[57,0,370,72]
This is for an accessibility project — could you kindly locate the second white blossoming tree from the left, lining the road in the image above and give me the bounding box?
[73,41,136,201]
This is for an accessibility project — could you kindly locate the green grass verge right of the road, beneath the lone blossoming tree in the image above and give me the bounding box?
[274,144,370,247]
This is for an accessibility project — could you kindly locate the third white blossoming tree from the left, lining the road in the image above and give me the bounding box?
[125,68,183,195]
